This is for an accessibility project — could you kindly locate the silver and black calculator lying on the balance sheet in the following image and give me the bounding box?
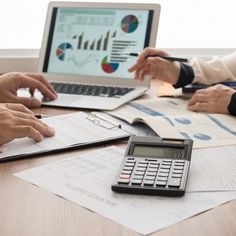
[111,136,193,197]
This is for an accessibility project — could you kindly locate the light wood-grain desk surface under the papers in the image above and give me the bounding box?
[0,81,236,236]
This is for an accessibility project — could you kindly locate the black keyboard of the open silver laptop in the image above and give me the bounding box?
[51,82,134,98]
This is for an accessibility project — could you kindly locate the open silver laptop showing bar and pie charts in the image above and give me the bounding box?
[38,2,160,110]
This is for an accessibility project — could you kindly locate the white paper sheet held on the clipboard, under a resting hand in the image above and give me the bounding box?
[0,112,129,159]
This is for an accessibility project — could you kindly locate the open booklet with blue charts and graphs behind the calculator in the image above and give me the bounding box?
[108,98,236,148]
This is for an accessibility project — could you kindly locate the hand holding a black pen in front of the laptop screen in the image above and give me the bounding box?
[129,48,180,85]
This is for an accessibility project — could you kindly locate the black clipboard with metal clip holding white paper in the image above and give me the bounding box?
[0,112,132,163]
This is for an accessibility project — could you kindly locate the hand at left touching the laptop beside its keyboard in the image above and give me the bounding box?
[0,72,57,108]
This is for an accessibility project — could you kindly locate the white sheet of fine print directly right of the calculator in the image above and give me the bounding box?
[187,146,236,192]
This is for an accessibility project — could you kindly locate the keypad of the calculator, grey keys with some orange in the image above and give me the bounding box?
[118,157,189,188]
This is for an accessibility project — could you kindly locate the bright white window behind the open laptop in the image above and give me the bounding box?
[0,0,236,49]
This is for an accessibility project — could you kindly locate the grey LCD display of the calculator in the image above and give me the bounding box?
[131,145,184,158]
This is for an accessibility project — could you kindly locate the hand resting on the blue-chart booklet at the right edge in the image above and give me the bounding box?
[187,84,235,114]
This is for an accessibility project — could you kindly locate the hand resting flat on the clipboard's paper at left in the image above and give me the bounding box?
[0,103,55,146]
